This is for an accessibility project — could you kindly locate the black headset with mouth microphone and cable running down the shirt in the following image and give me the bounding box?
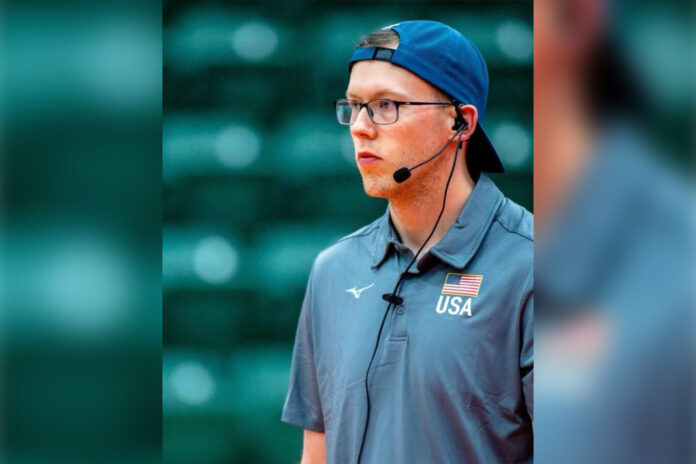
[357,100,469,464]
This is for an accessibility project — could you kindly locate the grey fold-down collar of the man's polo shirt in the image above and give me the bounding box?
[372,173,504,269]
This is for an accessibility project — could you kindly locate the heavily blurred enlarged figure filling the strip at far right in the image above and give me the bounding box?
[534,0,696,463]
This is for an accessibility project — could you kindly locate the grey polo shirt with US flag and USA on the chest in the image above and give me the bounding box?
[282,174,534,464]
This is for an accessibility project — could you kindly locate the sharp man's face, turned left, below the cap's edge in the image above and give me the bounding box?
[346,60,454,199]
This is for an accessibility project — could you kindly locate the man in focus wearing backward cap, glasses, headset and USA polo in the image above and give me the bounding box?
[282,21,533,464]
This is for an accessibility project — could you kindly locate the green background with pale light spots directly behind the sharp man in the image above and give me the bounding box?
[162,0,533,464]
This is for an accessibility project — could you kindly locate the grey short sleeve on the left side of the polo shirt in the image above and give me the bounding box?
[281,264,324,432]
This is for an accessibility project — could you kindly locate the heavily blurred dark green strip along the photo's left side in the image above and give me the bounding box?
[0,0,162,464]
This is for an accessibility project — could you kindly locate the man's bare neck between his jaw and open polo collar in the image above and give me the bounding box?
[389,171,474,258]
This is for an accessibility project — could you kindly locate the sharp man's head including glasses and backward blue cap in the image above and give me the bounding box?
[346,21,502,198]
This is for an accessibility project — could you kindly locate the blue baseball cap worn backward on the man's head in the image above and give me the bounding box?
[348,20,505,176]
